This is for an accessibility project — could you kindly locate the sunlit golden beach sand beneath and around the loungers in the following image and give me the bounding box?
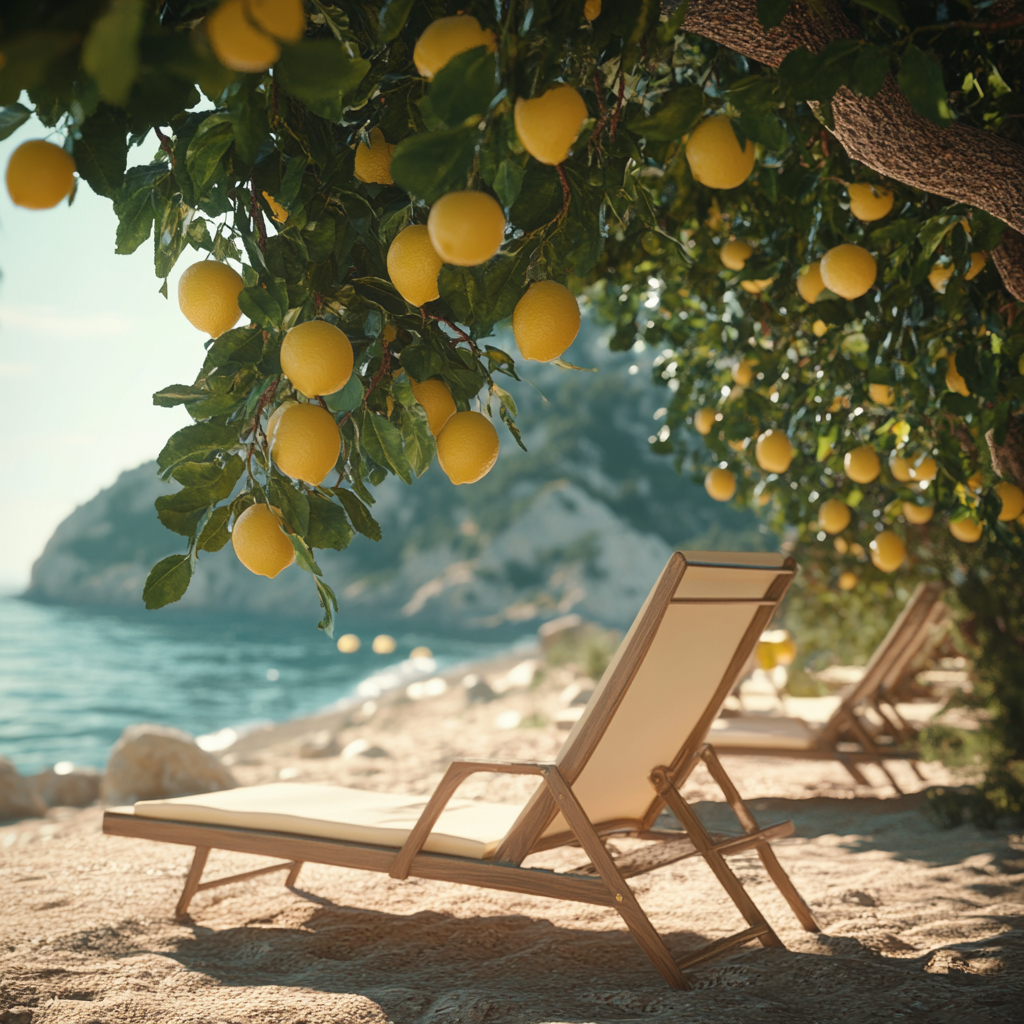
[0,659,1024,1024]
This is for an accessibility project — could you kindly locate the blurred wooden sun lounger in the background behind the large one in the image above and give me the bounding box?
[710,583,949,793]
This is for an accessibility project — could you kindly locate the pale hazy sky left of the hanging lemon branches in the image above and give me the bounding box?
[0,119,201,591]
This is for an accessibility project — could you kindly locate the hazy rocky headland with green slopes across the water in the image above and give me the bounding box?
[27,331,774,629]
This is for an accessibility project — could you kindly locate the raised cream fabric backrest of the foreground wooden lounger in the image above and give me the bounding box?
[499,552,795,859]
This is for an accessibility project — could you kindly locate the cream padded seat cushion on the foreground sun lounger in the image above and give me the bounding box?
[135,782,521,860]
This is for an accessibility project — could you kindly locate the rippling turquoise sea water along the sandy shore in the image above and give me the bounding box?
[0,597,517,773]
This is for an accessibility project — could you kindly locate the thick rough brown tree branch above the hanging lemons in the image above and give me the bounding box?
[683,0,1024,301]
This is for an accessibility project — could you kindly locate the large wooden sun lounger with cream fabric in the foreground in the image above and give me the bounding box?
[103,552,817,988]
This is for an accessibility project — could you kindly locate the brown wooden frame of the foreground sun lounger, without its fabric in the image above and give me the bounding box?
[103,553,818,988]
